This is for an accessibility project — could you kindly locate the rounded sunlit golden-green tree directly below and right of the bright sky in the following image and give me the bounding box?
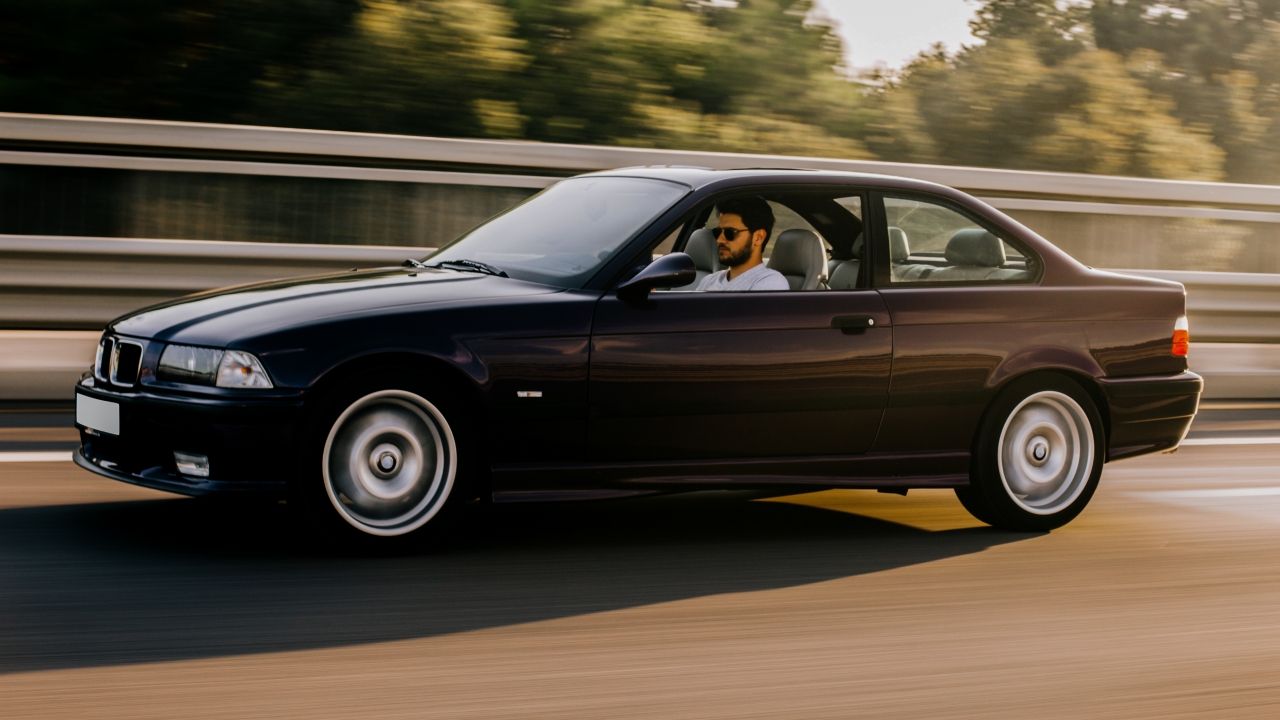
[868,38,1222,179]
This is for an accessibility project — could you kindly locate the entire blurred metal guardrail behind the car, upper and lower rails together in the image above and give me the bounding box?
[0,113,1280,398]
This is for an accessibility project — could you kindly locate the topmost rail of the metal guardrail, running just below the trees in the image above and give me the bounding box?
[0,113,1280,210]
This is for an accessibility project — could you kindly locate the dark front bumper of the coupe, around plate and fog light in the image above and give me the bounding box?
[73,378,303,497]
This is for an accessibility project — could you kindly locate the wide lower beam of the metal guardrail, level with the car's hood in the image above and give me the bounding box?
[0,236,1280,338]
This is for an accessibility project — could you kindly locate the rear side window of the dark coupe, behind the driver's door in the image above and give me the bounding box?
[884,196,1033,283]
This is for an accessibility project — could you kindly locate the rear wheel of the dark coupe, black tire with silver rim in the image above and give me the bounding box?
[956,375,1106,532]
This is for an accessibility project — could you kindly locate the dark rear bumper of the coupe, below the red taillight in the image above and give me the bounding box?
[1098,372,1204,461]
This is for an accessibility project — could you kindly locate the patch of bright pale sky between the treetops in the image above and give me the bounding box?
[815,0,978,69]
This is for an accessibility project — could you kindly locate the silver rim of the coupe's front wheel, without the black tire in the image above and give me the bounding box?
[317,388,458,537]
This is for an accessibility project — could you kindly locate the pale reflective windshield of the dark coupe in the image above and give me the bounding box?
[428,177,689,287]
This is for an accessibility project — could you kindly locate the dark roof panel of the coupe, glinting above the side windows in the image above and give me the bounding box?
[576,165,955,193]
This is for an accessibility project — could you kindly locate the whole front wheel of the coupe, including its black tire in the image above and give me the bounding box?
[294,378,470,538]
